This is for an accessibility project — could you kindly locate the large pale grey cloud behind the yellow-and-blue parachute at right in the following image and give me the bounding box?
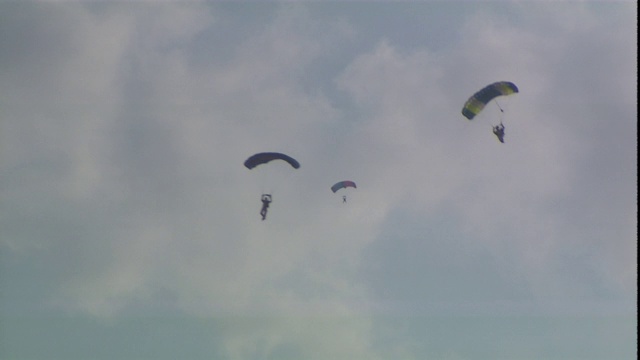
[330,1,635,314]
